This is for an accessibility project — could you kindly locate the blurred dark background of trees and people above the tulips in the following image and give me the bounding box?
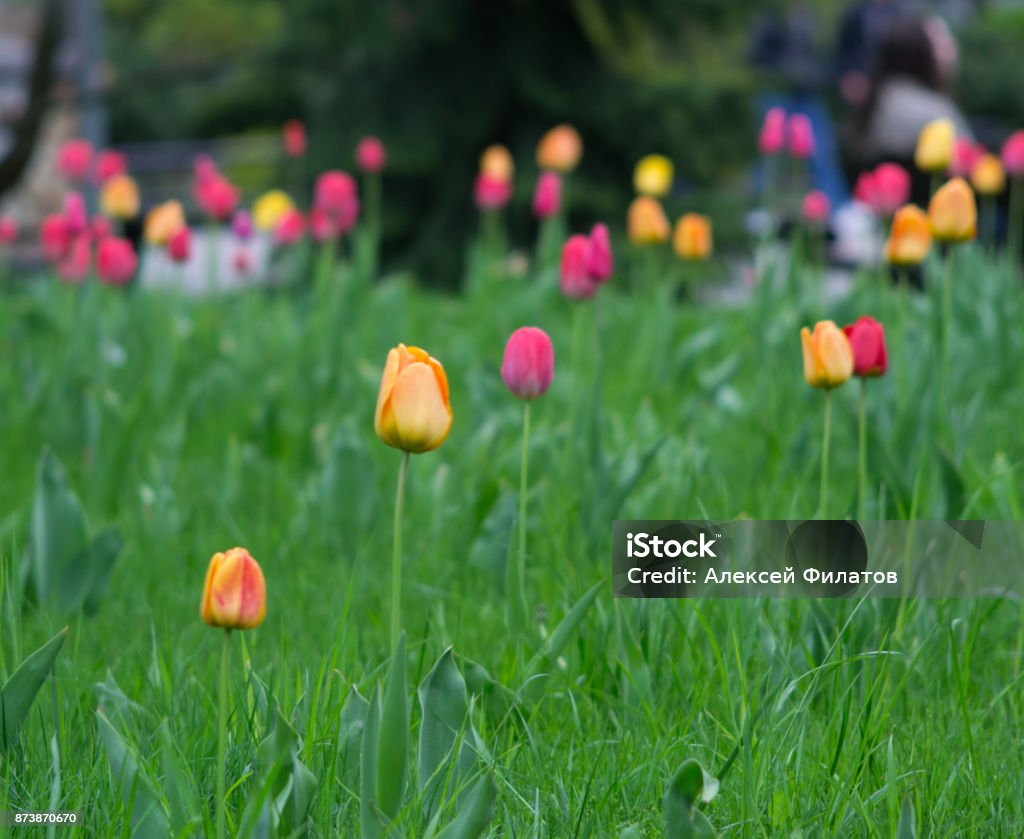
[0,0,1024,286]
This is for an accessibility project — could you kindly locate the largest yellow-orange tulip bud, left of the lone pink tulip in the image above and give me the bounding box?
[374,344,452,455]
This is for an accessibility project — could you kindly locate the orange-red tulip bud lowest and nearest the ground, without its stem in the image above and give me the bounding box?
[199,548,266,629]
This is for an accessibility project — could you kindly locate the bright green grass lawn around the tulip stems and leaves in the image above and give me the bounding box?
[0,237,1024,837]
